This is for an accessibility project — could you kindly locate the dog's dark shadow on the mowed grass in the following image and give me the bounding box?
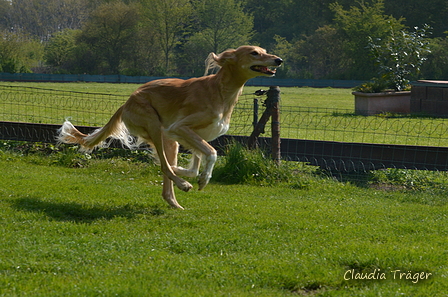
[11,197,165,223]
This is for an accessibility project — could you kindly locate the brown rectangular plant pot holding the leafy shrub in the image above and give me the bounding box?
[352,91,411,115]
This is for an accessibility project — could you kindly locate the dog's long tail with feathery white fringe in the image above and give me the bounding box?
[56,106,135,153]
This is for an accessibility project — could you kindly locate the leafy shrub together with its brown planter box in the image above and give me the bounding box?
[353,25,430,115]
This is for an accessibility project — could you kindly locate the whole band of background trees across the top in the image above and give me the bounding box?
[0,0,448,79]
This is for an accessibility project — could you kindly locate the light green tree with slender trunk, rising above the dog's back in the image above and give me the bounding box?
[143,0,192,73]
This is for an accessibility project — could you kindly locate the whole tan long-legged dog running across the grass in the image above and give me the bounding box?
[57,46,283,208]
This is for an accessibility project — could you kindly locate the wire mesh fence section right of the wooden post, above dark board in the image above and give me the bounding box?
[281,106,448,147]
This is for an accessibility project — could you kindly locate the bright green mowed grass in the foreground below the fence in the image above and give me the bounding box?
[0,144,448,296]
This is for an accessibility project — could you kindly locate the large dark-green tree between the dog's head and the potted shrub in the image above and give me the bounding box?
[270,0,410,79]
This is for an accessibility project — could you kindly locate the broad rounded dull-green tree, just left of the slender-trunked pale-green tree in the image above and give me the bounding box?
[77,1,139,74]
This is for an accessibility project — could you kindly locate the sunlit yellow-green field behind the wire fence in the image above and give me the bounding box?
[0,82,448,146]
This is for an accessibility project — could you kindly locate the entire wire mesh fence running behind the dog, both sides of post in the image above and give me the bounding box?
[0,86,448,171]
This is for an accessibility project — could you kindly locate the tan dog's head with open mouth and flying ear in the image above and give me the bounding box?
[206,45,283,78]
